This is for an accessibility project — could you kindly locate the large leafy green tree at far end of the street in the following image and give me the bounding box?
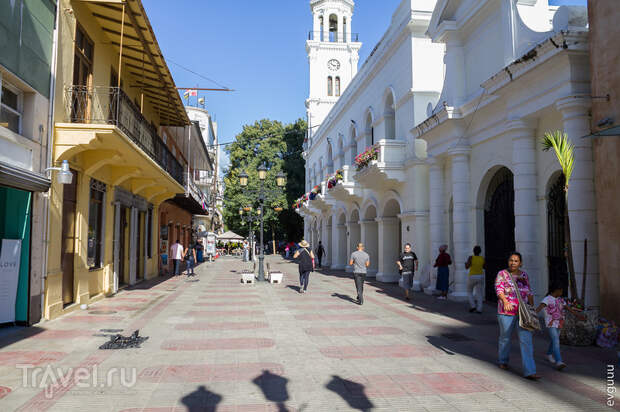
[224,119,307,241]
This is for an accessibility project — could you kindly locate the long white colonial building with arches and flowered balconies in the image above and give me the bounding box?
[299,0,598,306]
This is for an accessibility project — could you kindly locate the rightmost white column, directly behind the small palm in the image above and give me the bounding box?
[556,96,599,306]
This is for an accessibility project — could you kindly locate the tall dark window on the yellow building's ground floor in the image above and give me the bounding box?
[87,179,106,269]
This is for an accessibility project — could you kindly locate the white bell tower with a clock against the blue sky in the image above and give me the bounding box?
[306,0,362,137]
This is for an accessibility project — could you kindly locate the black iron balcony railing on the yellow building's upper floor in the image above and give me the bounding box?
[65,86,185,186]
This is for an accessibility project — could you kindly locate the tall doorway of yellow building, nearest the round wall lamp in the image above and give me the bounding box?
[60,169,77,306]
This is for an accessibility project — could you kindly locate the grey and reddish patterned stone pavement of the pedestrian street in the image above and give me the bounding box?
[0,257,620,412]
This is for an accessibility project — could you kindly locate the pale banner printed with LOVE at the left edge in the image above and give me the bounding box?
[0,239,22,323]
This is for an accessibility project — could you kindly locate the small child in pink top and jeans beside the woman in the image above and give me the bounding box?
[536,284,586,370]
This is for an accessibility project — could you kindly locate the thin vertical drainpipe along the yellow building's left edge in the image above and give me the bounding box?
[39,2,61,321]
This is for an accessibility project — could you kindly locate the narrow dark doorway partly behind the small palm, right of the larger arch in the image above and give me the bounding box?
[547,174,568,296]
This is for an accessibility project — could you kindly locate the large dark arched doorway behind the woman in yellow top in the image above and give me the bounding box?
[484,167,515,302]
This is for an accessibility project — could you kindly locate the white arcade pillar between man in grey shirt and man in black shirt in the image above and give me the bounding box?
[376,217,401,282]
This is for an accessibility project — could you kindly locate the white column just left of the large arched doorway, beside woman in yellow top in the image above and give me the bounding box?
[448,146,472,300]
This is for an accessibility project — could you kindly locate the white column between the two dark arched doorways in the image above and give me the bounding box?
[507,120,536,295]
